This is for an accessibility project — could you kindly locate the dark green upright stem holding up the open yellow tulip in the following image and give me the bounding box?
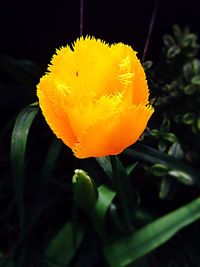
[110,156,133,230]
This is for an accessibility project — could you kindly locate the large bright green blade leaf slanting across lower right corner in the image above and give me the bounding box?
[104,198,200,267]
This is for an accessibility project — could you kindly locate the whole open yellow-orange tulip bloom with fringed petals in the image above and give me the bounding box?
[37,37,153,158]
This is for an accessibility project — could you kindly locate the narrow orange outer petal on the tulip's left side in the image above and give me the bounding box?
[37,76,77,147]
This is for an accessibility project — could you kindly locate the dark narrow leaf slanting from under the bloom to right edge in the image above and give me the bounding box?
[124,143,200,185]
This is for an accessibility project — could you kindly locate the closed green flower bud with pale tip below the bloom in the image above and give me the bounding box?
[72,169,98,216]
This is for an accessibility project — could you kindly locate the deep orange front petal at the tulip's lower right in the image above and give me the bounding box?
[72,105,153,158]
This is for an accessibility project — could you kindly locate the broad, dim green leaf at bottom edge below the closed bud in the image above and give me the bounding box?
[42,222,84,267]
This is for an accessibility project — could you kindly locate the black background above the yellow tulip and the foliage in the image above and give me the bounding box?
[0,0,200,66]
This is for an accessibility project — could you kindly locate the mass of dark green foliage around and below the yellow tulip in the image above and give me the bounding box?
[0,26,200,267]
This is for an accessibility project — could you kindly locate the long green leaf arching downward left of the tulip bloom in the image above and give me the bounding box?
[11,105,39,226]
